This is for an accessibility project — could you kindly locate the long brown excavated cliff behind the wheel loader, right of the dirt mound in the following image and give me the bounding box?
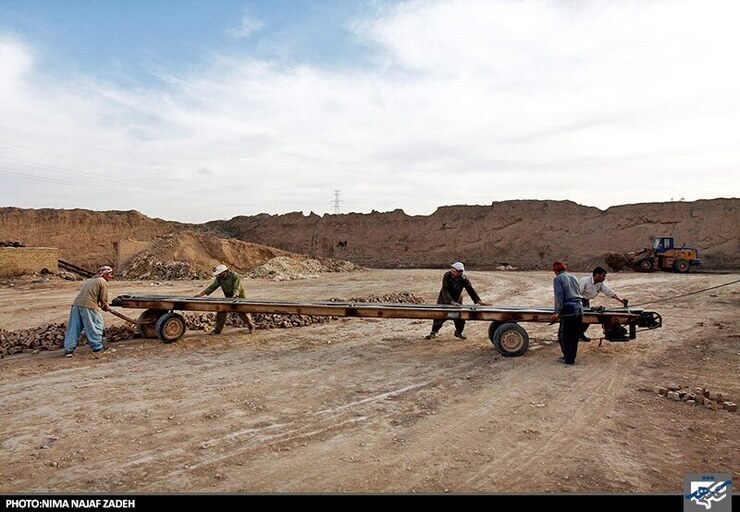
[207,199,740,270]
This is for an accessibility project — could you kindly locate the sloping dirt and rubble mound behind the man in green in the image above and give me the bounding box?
[120,231,360,280]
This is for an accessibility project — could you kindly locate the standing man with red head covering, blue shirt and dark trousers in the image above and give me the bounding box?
[550,261,583,364]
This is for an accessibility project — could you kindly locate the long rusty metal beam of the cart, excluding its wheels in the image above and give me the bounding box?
[111,295,643,324]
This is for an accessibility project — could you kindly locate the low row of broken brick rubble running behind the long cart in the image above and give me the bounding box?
[0,293,424,358]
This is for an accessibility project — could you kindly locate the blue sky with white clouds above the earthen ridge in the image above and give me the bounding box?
[0,0,740,223]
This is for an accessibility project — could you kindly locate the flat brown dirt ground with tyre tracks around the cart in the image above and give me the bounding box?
[0,270,740,493]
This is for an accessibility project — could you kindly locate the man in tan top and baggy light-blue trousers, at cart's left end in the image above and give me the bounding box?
[64,265,113,357]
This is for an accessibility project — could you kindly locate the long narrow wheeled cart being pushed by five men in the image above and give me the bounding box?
[111,295,662,356]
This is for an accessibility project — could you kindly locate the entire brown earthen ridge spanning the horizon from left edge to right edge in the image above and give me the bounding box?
[0,199,740,270]
